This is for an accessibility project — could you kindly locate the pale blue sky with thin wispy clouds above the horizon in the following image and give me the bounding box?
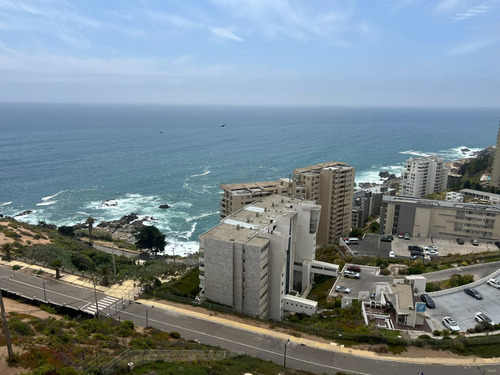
[0,0,500,108]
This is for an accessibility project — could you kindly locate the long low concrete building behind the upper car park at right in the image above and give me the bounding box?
[380,196,500,241]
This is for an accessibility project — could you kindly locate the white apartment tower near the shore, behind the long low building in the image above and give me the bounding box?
[399,156,448,198]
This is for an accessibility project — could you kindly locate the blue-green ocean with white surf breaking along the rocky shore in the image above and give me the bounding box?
[0,103,500,255]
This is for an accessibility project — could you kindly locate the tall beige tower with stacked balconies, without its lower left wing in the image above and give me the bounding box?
[293,161,355,246]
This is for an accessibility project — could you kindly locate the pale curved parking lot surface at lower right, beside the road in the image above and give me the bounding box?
[427,282,500,331]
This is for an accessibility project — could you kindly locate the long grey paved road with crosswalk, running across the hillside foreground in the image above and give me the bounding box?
[0,267,500,375]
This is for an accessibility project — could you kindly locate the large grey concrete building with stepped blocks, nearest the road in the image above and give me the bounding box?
[199,194,338,320]
